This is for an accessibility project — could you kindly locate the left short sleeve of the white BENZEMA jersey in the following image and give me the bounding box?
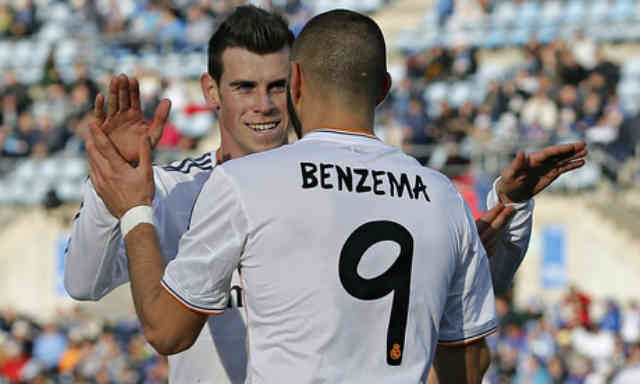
[162,167,248,314]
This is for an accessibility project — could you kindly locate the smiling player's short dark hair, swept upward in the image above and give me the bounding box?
[208,5,295,83]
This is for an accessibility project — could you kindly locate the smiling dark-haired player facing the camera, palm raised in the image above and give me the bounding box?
[65,6,294,383]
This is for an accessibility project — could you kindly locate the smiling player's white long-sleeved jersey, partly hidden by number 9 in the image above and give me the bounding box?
[64,134,533,384]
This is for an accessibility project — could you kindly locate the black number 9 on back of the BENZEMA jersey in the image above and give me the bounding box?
[338,221,413,365]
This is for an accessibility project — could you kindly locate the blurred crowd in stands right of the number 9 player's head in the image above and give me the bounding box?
[384,33,640,175]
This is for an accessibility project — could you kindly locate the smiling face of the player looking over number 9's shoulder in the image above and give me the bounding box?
[203,47,289,158]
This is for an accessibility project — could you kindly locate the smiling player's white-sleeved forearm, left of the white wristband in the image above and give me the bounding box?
[64,182,129,300]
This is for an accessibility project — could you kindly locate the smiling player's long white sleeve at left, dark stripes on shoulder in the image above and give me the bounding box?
[64,153,213,301]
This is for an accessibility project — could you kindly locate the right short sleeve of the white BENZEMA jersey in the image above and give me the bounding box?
[438,197,497,346]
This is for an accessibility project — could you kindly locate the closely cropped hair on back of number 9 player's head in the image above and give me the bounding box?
[291,9,387,97]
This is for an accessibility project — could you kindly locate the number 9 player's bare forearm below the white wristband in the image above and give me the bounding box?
[125,223,206,354]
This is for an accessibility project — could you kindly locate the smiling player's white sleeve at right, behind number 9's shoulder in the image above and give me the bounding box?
[487,178,535,294]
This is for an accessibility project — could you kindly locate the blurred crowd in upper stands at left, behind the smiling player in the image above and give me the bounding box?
[0,0,311,165]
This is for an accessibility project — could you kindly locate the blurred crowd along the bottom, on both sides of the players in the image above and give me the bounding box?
[0,287,640,384]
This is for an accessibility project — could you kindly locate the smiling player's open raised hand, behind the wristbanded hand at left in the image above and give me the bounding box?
[94,74,171,163]
